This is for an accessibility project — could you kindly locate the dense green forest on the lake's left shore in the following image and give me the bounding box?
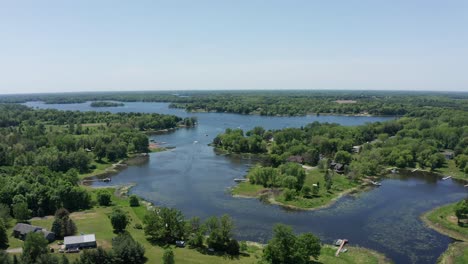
[0,104,196,219]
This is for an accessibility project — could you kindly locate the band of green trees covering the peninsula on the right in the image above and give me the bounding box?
[213,107,468,176]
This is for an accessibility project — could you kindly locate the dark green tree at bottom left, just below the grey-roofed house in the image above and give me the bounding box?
[21,233,49,264]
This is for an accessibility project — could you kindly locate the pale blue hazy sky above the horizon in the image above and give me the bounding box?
[0,0,468,94]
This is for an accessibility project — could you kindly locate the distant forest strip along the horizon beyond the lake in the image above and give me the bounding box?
[0,90,468,116]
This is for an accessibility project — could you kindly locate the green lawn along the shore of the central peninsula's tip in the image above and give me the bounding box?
[231,169,359,209]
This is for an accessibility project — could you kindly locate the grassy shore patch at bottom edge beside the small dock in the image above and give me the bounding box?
[313,245,392,264]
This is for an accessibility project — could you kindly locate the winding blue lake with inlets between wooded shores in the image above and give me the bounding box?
[26,102,467,263]
